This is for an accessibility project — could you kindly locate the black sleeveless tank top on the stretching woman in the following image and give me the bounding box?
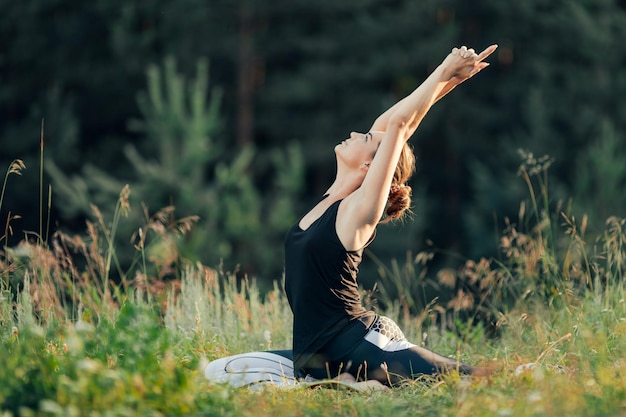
[285,200,376,370]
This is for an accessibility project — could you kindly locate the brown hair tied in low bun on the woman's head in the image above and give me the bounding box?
[381,143,415,223]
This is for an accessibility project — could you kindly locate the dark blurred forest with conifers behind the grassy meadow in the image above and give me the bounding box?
[0,0,626,292]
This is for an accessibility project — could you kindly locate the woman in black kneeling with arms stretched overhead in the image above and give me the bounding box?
[285,45,497,384]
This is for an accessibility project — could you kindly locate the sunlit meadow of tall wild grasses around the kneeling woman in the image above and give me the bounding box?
[0,156,626,417]
